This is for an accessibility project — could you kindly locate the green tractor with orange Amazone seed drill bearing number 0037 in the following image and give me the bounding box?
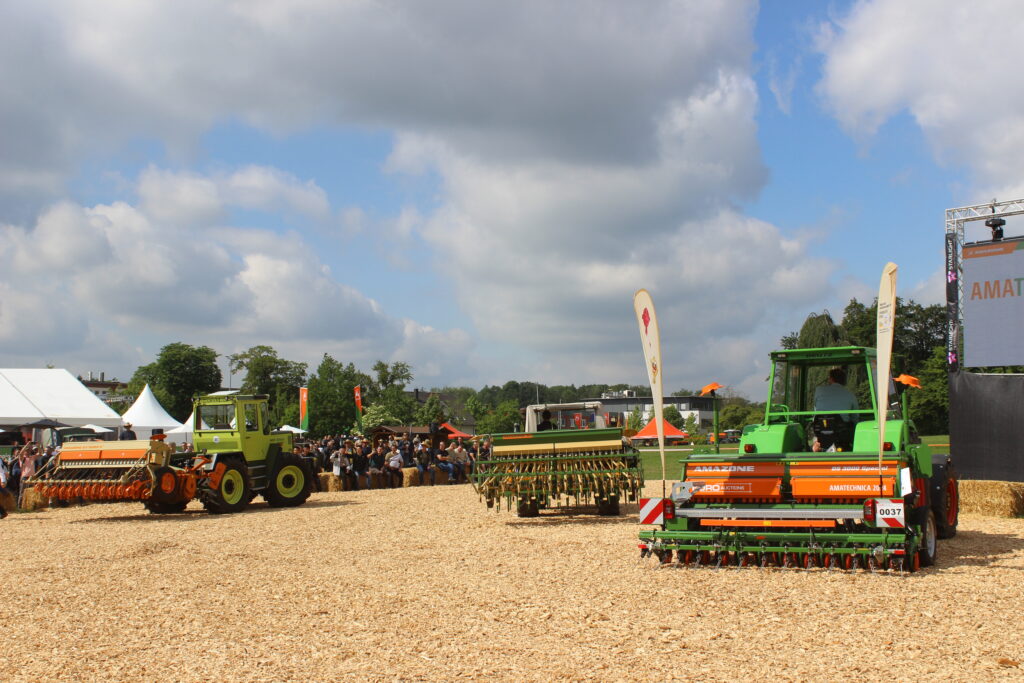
[640,346,959,571]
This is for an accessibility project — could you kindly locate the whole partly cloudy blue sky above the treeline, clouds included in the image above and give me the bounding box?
[0,0,1024,395]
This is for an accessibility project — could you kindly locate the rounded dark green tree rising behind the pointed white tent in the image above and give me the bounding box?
[128,342,221,421]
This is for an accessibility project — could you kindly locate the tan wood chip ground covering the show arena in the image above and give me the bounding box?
[0,483,1024,681]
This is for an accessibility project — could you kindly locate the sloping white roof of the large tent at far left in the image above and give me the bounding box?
[0,368,121,429]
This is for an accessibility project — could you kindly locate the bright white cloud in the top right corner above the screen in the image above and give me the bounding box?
[817,0,1024,199]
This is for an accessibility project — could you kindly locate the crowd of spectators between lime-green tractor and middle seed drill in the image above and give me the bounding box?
[295,434,490,489]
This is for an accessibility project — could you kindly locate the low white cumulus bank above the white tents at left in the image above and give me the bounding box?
[0,163,472,374]
